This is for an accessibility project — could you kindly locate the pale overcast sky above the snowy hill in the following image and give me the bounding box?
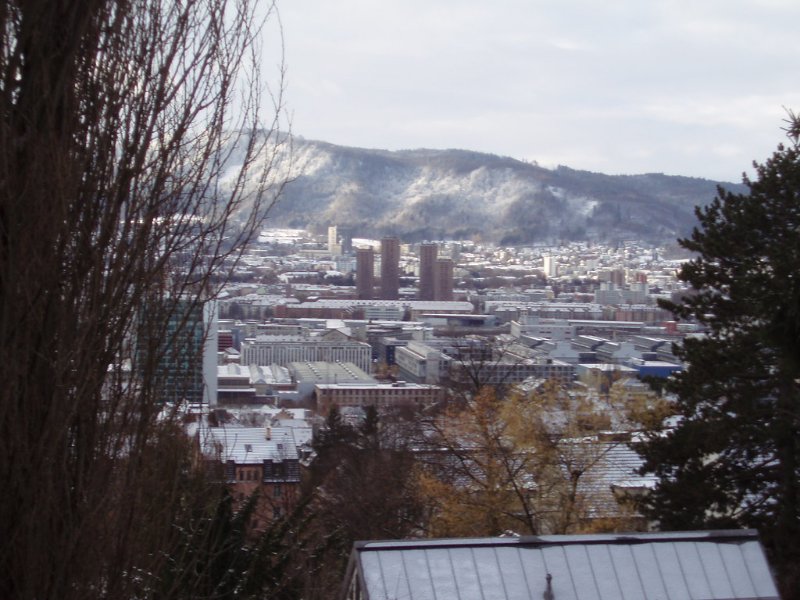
[279,0,800,181]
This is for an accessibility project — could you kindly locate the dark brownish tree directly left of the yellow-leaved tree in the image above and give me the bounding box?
[303,405,424,600]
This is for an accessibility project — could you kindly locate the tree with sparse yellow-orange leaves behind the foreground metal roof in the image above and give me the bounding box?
[419,382,641,537]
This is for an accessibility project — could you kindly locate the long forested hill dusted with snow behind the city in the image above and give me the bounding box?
[270,138,742,244]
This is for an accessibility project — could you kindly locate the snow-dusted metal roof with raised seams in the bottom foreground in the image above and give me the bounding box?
[353,530,778,600]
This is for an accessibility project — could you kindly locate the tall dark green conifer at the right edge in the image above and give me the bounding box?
[638,113,800,598]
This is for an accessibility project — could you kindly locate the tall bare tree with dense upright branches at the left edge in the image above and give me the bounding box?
[0,0,287,599]
